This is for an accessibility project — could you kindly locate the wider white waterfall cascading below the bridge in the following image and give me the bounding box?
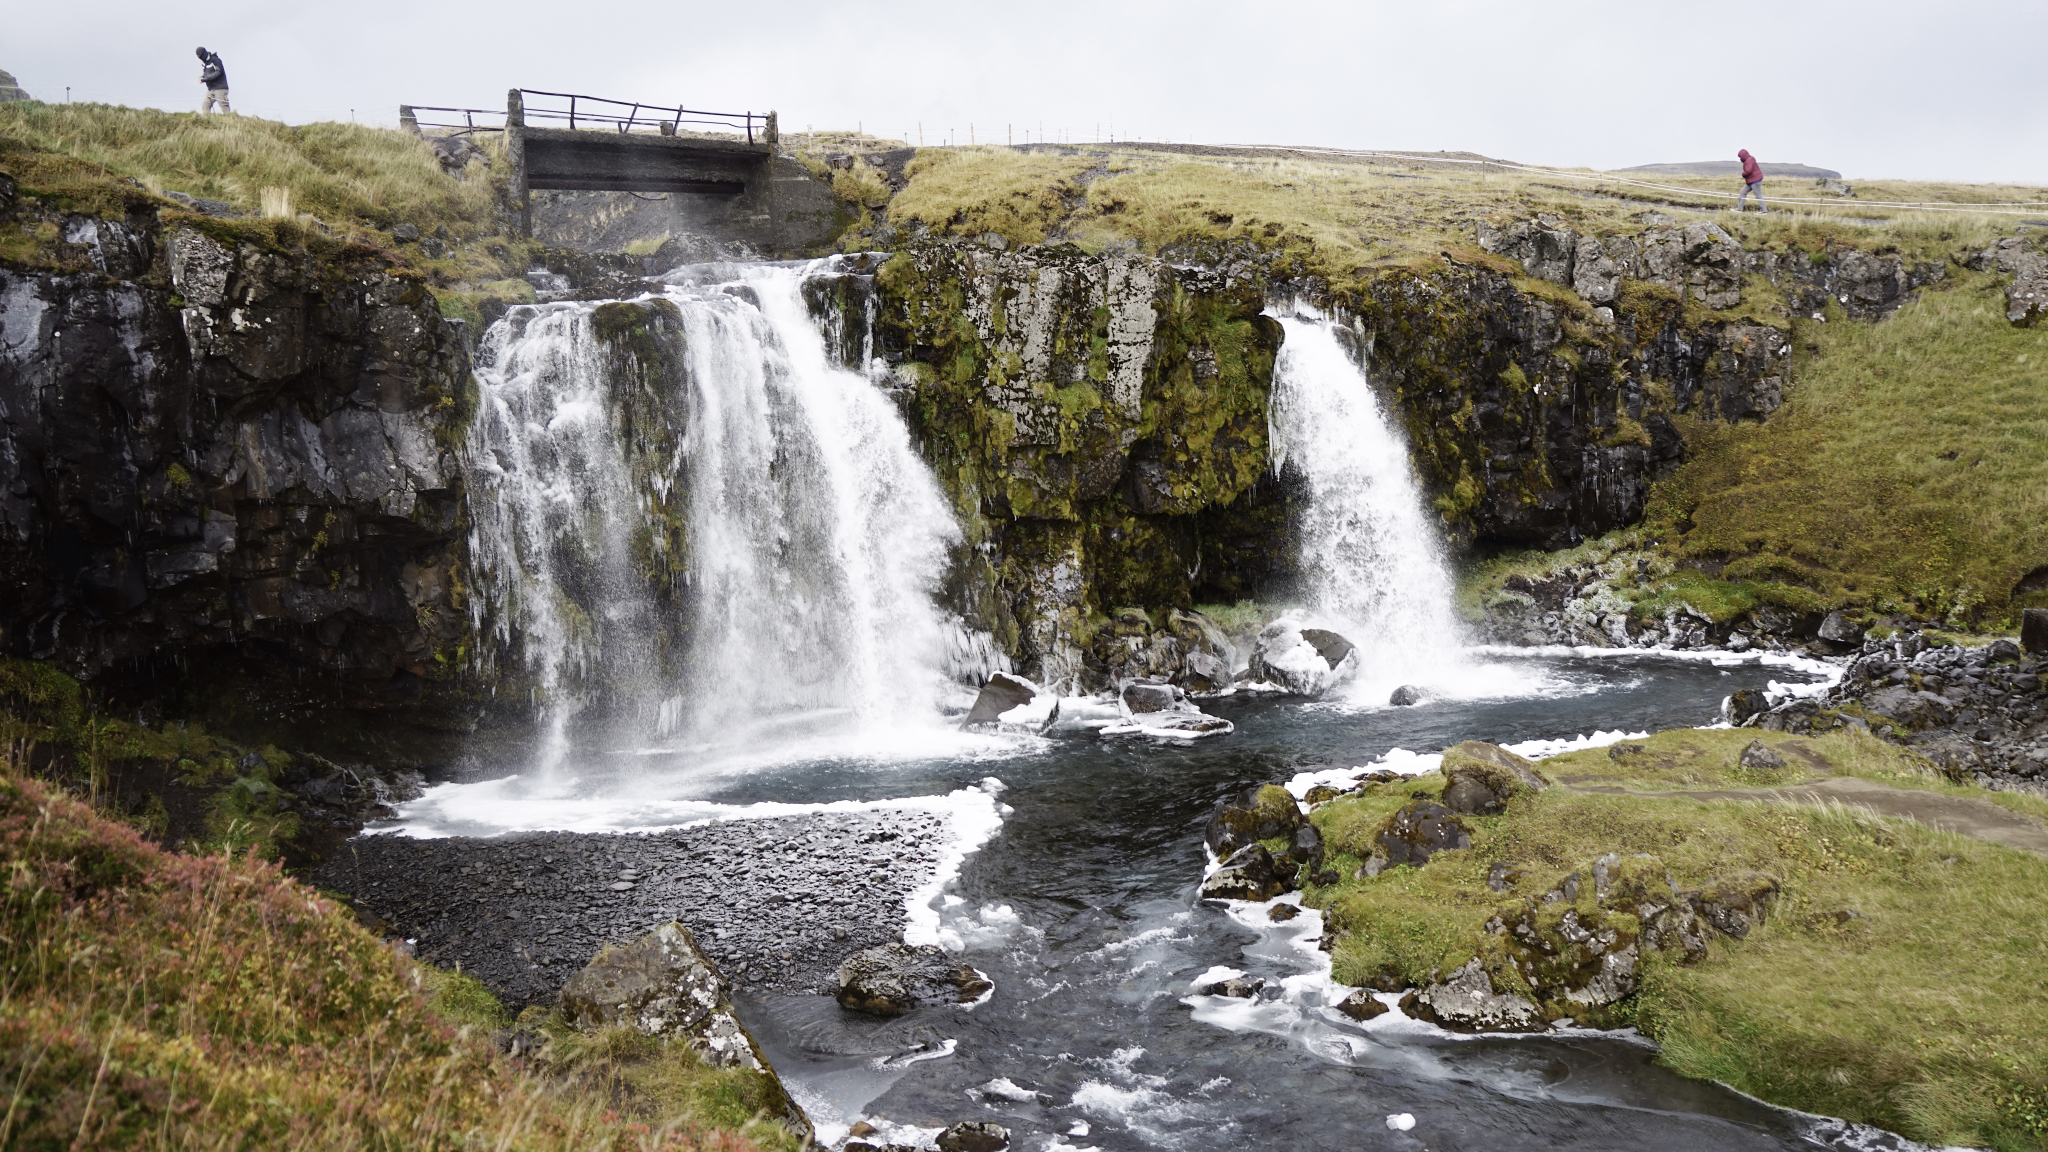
[465,260,987,767]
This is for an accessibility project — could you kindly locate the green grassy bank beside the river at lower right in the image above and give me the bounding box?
[1309,732,2048,1150]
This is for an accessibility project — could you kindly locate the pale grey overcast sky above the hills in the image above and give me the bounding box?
[16,0,2048,184]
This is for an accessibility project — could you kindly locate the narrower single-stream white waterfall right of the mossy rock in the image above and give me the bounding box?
[1272,305,1464,701]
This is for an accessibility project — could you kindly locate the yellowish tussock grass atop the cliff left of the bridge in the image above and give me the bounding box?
[0,100,504,234]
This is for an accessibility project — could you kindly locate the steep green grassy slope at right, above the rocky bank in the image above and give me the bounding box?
[1645,277,2048,625]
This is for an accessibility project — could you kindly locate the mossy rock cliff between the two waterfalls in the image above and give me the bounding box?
[877,242,1284,689]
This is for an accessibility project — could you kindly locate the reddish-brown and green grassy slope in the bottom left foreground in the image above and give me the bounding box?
[0,758,795,1152]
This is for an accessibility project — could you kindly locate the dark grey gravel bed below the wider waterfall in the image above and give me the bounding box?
[315,812,948,1009]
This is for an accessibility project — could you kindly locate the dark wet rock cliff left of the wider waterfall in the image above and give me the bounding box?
[0,215,471,725]
